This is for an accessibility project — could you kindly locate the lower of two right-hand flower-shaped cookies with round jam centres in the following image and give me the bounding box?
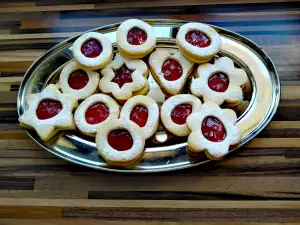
[187,101,242,160]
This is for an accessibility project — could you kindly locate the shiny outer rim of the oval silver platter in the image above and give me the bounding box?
[17,18,281,174]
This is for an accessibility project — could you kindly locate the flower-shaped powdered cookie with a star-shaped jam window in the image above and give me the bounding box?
[99,54,149,101]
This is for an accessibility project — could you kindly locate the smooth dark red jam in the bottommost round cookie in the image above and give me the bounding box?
[107,129,133,151]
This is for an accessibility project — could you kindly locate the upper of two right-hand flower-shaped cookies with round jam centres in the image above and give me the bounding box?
[190,57,248,106]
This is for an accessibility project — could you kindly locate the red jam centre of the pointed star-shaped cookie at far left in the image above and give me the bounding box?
[36,99,62,120]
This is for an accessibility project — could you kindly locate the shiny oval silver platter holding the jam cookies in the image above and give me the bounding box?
[17,19,280,173]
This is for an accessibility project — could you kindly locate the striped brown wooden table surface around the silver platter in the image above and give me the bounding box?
[0,0,300,225]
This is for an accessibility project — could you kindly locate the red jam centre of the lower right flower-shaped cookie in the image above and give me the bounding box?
[201,116,226,142]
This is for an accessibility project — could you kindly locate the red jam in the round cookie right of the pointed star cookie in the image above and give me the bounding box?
[85,103,109,124]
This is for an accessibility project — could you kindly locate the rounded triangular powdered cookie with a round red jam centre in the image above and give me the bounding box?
[149,48,194,95]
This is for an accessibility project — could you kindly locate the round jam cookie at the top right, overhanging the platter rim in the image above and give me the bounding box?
[176,23,221,63]
